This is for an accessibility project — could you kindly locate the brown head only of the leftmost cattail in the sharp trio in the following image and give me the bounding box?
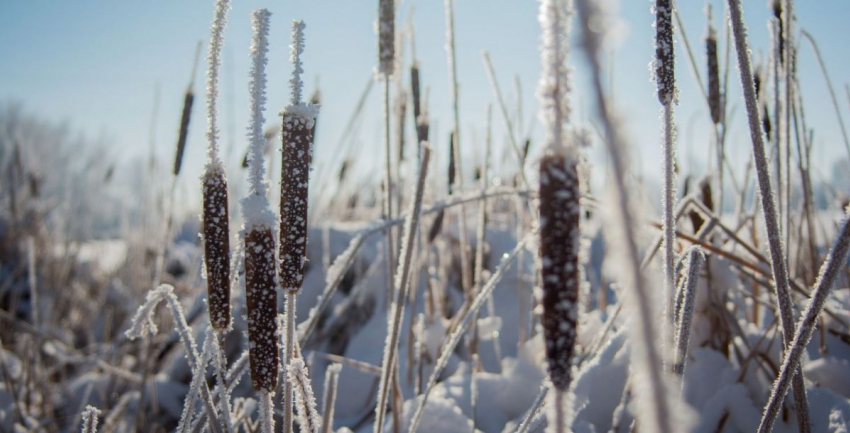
[202,165,230,331]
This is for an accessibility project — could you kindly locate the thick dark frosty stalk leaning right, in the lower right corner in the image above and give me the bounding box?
[758,208,850,433]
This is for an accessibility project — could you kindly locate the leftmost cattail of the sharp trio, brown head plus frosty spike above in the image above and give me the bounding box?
[201,0,230,331]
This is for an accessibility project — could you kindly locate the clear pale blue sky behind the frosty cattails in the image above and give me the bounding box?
[0,0,850,213]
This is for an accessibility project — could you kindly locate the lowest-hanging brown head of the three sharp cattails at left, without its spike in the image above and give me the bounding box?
[245,224,280,392]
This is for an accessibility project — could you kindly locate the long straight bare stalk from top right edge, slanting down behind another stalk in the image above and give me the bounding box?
[728,0,810,431]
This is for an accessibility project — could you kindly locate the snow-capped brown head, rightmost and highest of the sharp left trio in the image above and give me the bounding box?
[280,104,318,291]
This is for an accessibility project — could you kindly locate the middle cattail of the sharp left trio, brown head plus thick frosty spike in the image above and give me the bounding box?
[242,9,280,394]
